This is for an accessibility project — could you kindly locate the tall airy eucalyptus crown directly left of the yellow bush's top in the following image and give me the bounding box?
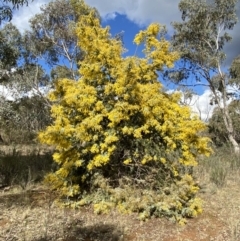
[24,0,100,80]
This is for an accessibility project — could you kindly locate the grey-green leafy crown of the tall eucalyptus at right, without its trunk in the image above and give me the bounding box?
[172,0,237,75]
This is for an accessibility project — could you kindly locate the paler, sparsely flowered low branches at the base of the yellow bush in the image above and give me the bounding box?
[77,174,202,224]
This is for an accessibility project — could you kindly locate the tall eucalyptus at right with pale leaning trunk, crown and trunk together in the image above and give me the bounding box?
[169,0,240,153]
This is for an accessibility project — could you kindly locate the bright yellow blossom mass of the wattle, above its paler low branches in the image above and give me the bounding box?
[39,0,211,222]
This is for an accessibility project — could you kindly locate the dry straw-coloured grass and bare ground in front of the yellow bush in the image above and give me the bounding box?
[0,146,240,241]
